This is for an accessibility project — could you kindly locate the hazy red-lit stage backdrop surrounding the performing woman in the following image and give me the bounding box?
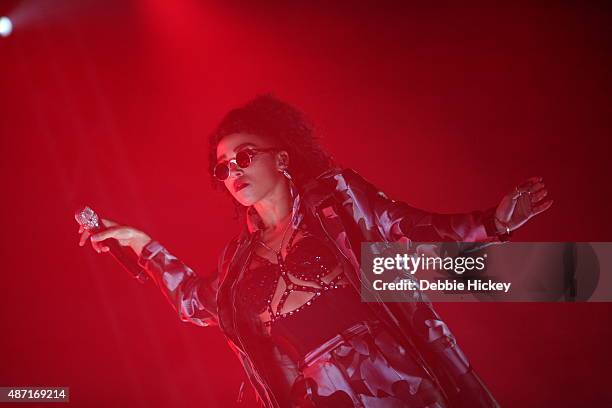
[0,0,612,407]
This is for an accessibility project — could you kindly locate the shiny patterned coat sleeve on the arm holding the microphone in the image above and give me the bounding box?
[138,241,219,326]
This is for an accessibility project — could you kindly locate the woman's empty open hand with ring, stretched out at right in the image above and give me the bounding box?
[495,177,553,232]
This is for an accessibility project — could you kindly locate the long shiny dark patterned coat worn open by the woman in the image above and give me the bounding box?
[139,169,499,408]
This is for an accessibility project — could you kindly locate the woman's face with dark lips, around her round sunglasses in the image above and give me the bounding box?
[217,133,287,206]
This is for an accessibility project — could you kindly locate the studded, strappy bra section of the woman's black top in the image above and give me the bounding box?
[238,218,346,326]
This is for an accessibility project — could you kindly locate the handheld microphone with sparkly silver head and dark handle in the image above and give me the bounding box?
[74,206,149,284]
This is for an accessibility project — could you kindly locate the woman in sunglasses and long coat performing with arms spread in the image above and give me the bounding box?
[80,95,552,407]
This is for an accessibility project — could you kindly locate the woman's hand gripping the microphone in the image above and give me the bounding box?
[79,218,151,256]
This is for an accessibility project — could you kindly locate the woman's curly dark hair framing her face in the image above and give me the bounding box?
[208,93,334,194]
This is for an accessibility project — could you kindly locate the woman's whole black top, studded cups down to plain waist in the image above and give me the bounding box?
[238,215,374,361]
